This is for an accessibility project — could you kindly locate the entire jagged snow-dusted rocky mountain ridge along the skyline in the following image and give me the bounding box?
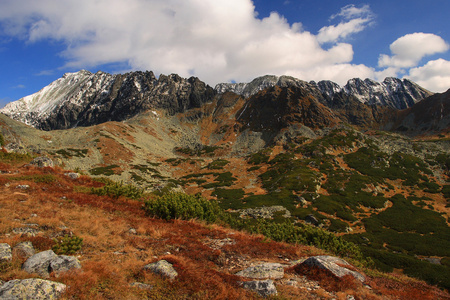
[0,70,432,130]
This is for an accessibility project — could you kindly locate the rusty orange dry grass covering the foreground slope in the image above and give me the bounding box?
[0,164,449,299]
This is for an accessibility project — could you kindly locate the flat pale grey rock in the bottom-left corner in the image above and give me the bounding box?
[0,278,66,300]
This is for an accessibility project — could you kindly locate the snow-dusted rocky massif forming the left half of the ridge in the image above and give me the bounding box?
[0,70,215,130]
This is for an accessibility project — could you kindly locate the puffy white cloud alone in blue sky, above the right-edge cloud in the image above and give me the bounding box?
[378,32,449,68]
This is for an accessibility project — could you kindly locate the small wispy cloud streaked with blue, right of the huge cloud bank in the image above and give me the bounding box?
[317,4,374,43]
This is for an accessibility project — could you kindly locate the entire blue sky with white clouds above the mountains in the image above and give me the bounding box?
[0,0,450,107]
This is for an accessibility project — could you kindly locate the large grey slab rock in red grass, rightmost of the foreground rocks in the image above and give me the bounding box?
[302,255,365,282]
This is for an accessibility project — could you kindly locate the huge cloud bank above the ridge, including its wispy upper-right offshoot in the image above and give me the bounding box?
[0,0,373,85]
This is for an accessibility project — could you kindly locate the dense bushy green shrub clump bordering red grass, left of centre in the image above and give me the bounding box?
[144,193,223,223]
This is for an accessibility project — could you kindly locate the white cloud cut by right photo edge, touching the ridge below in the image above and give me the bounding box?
[405,59,450,92]
